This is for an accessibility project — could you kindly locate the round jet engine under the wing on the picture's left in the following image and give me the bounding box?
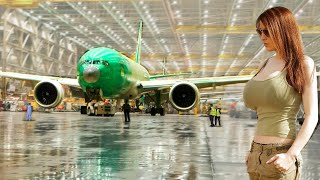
[34,80,64,108]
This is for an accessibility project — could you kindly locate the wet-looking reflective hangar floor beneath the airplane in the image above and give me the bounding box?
[0,112,320,180]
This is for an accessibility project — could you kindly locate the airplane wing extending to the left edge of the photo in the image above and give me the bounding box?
[0,71,80,88]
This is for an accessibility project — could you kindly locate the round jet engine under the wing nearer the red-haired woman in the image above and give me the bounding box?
[169,82,200,111]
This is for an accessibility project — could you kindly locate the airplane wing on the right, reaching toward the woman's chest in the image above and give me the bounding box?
[140,75,253,90]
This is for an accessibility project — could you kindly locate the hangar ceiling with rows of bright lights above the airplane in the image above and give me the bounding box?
[0,0,320,97]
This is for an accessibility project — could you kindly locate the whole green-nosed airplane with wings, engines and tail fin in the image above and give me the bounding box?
[0,21,252,115]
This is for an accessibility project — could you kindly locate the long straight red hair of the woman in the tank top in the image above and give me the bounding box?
[256,7,308,93]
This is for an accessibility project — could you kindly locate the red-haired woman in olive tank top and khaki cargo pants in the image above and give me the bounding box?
[243,7,318,179]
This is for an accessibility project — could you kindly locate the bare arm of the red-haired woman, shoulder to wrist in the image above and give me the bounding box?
[287,57,318,157]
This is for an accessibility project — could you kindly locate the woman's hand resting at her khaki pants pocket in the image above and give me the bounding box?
[266,153,296,173]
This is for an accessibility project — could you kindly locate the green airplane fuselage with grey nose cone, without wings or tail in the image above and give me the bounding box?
[77,47,150,99]
